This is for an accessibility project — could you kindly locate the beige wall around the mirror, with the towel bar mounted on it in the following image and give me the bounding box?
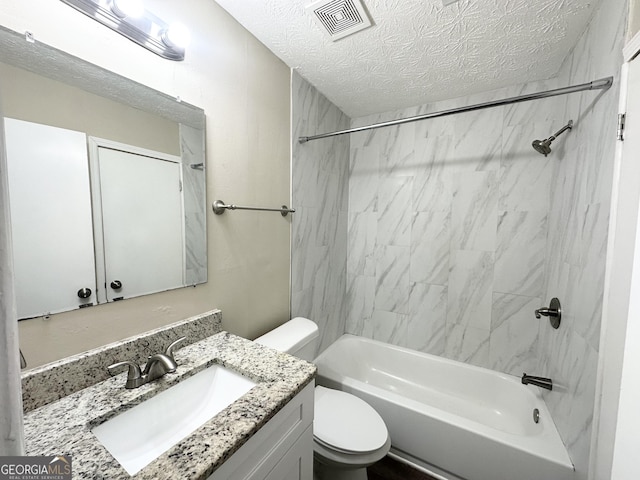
[0,0,290,366]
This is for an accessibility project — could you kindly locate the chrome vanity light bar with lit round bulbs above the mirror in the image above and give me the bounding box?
[61,0,190,61]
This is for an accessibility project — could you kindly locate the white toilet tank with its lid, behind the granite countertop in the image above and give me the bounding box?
[254,317,319,362]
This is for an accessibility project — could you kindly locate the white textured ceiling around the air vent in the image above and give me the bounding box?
[217,0,599,117]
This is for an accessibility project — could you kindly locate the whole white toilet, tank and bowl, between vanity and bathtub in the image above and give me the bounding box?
[255,317,391,480]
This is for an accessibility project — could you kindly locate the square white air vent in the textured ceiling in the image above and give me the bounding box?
[305,0,371,41]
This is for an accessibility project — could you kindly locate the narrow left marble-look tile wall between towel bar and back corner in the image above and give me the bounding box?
[291,71,350,351]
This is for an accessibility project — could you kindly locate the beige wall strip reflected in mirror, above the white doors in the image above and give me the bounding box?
[0,63,180,155]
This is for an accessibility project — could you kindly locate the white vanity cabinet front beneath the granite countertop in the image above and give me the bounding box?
[208,382,314,480]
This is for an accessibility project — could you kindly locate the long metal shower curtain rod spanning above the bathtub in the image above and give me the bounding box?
[298,77,613,143]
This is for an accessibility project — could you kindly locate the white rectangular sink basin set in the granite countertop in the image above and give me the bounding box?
[92,365,256,475]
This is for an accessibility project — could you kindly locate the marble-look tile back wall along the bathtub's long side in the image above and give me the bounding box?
[346,81,564,375]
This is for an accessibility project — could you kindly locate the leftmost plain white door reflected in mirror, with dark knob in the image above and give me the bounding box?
[5,118,96,318]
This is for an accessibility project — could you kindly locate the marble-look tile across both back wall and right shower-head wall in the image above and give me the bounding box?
[346,0,627,479]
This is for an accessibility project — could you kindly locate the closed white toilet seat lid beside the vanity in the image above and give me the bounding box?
[313,386,389,453]
